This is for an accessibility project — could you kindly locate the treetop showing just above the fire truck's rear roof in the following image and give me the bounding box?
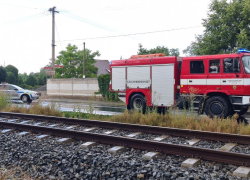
[137,44,180,56]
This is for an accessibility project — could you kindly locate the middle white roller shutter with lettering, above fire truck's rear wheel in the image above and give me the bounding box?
[127,66,151,89]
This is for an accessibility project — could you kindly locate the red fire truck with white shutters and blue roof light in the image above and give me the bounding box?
[110,49,250,117]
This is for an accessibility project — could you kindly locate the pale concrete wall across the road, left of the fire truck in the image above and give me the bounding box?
[47,78,99,96]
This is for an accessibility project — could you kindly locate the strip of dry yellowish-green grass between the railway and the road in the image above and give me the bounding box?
[0,96,250,135]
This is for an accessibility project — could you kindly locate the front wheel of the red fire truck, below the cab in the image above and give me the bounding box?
[204,96,230,118]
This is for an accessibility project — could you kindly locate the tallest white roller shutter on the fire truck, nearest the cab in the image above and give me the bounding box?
[152,64,175,106]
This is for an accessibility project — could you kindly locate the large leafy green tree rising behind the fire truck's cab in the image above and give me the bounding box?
[183,0,250,55]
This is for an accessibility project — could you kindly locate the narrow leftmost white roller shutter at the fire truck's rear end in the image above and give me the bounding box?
[112,67,126,91]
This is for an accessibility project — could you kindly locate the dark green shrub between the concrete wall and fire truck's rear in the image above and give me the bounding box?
[98,74,119,101]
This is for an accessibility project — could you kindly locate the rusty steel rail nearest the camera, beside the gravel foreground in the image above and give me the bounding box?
[0,121,250,165]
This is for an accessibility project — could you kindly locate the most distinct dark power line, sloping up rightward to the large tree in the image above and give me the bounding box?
[56,26,203,41]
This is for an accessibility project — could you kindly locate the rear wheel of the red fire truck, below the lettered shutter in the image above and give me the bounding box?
[129,94,146,113]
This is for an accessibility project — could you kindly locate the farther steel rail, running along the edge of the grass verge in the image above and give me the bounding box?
[0,112,250,145]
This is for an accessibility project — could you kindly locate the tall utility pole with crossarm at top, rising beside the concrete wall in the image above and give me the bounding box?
[49,6,59,78]
